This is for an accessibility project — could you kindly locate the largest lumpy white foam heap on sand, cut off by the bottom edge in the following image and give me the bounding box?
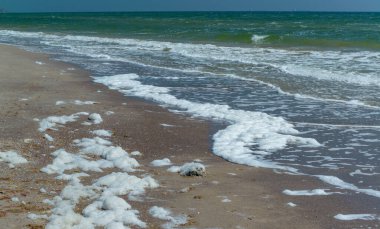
[46,173,158,229]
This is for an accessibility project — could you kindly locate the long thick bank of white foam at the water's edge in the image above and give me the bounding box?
[95,74,321,172]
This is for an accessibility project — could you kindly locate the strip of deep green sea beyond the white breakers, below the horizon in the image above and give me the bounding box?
[0,12,380,49]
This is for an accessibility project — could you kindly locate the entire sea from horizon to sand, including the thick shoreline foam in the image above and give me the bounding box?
[0,12,380,218]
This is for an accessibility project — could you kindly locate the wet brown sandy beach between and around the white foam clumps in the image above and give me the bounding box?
[0,43,377,228]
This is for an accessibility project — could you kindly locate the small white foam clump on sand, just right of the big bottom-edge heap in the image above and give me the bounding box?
[149,206,187,229]
